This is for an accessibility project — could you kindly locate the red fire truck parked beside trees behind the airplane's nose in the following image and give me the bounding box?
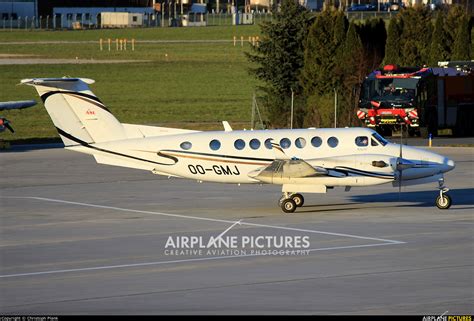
[357,62,474,137]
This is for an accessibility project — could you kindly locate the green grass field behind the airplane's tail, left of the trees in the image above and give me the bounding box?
[0,26,257,141]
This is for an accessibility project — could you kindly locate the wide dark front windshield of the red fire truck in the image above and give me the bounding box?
[362,78,419,103]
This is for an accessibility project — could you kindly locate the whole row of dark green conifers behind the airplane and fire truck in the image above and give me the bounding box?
[247,0,474,128]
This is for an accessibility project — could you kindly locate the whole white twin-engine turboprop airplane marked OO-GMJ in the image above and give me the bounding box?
[21,78,454,213]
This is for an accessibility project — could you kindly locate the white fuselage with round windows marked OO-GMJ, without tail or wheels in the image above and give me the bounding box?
[69,128,453,186]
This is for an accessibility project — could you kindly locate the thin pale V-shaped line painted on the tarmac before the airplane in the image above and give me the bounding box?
[0,196,406,279]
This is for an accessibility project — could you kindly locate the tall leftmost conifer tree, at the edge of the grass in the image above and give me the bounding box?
[247,0,309,127]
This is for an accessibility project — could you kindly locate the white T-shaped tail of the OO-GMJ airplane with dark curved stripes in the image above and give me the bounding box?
[21,78,126,146]
